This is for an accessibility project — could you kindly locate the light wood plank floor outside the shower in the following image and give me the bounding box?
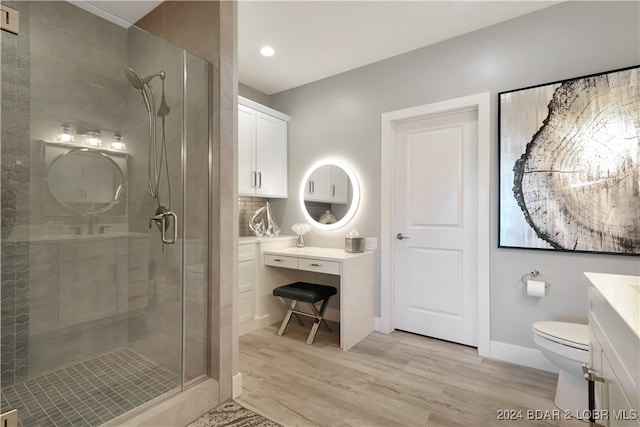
[236,319,587,427]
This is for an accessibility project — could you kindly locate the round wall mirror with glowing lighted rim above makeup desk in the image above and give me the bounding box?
[300,160,360,230]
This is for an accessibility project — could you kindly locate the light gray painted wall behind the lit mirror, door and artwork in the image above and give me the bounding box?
[269,2,640,348]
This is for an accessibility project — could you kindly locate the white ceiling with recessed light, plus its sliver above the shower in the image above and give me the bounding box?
[72,0,560,95]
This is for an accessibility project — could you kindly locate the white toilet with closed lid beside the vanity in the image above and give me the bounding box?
[533,321,589,416]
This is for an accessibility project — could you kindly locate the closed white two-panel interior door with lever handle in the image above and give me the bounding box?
[394,109,478,346]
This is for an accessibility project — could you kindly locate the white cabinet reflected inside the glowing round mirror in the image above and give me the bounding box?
[304,165,349,204]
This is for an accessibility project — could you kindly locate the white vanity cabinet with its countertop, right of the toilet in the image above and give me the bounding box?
[585,273,640,427]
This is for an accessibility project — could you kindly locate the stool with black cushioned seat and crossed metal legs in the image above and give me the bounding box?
[273,282,338,344]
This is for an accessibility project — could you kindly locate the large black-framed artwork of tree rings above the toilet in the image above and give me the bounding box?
[498,66,640,255]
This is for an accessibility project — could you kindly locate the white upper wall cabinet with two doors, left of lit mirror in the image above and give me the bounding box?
[238,96,290,198]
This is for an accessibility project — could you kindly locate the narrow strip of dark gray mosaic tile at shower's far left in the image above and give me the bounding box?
[0,1,31,386]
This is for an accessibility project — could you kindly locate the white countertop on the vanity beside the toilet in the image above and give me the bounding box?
[584,273,640,338]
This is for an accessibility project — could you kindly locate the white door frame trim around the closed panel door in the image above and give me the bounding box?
[377,92,491,356]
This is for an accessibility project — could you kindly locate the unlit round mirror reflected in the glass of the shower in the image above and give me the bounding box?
[47,148,125,215]
